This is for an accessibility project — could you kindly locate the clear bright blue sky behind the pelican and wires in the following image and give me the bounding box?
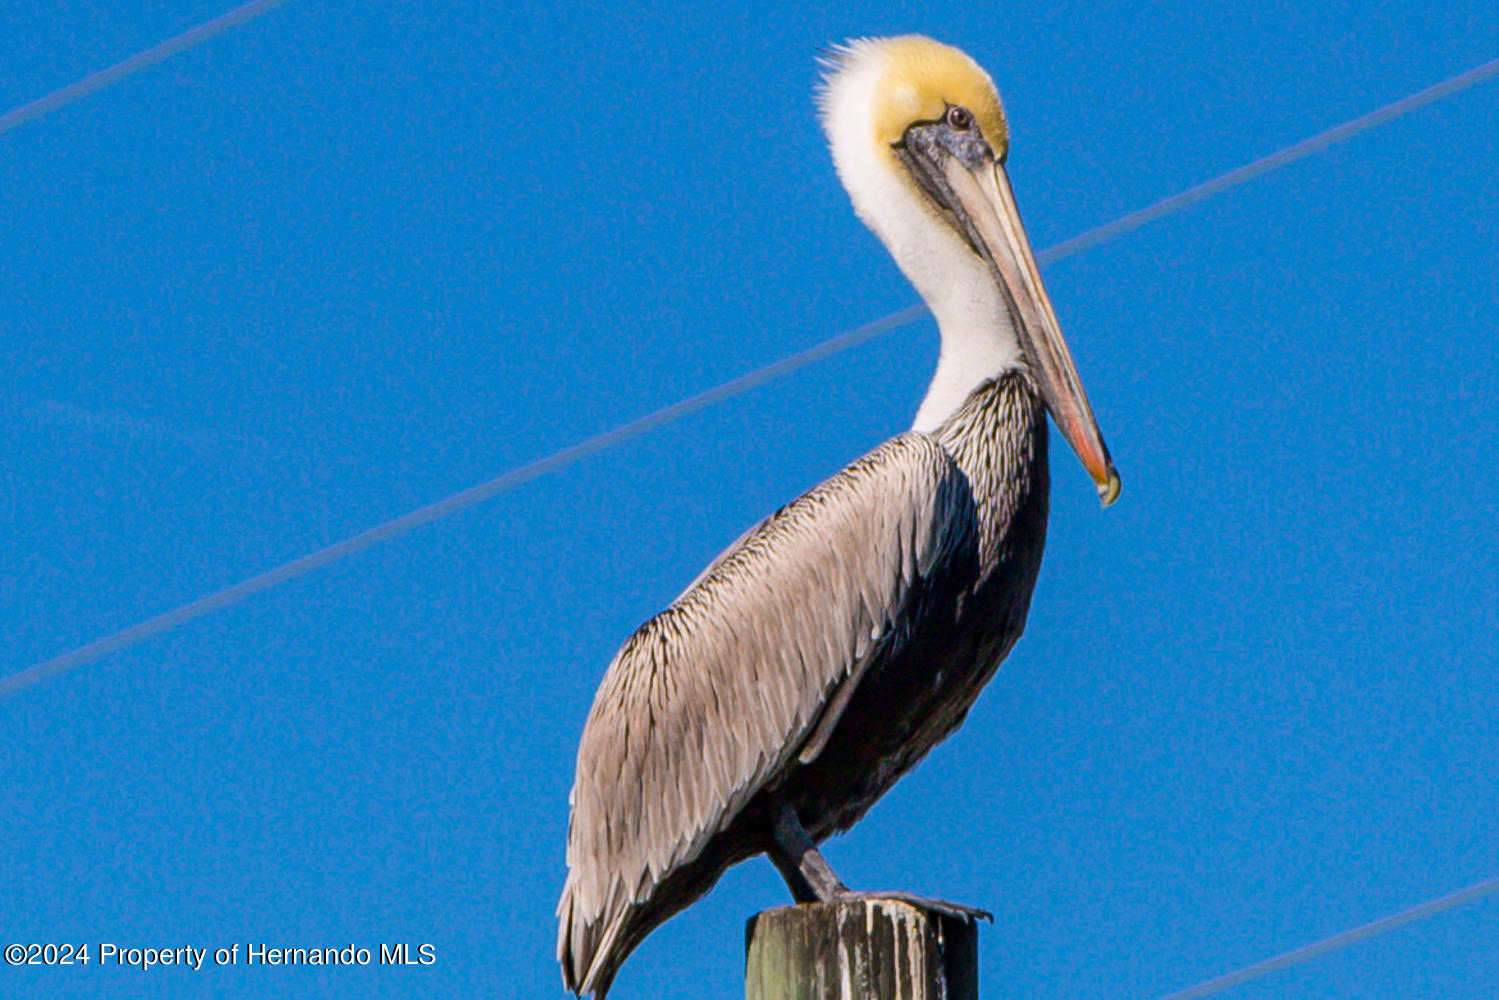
[0,0,1499,1000]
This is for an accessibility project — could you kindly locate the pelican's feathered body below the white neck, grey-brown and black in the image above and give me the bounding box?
[558,372,1048,996]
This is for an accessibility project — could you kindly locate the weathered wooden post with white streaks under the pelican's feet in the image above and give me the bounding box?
[745,900,979,1000]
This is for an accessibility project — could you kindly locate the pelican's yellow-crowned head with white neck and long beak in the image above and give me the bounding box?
[820,34,1120,507]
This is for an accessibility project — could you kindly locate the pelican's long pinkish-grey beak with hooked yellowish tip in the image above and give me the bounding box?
[943,156,1120,507]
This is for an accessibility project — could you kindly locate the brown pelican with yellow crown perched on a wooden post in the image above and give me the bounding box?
[558,36,1120,997]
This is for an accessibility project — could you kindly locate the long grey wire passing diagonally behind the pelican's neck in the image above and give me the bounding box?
[0,54,1499,697]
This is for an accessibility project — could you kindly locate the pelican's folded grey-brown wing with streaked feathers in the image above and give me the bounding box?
[558,432,974,991]
